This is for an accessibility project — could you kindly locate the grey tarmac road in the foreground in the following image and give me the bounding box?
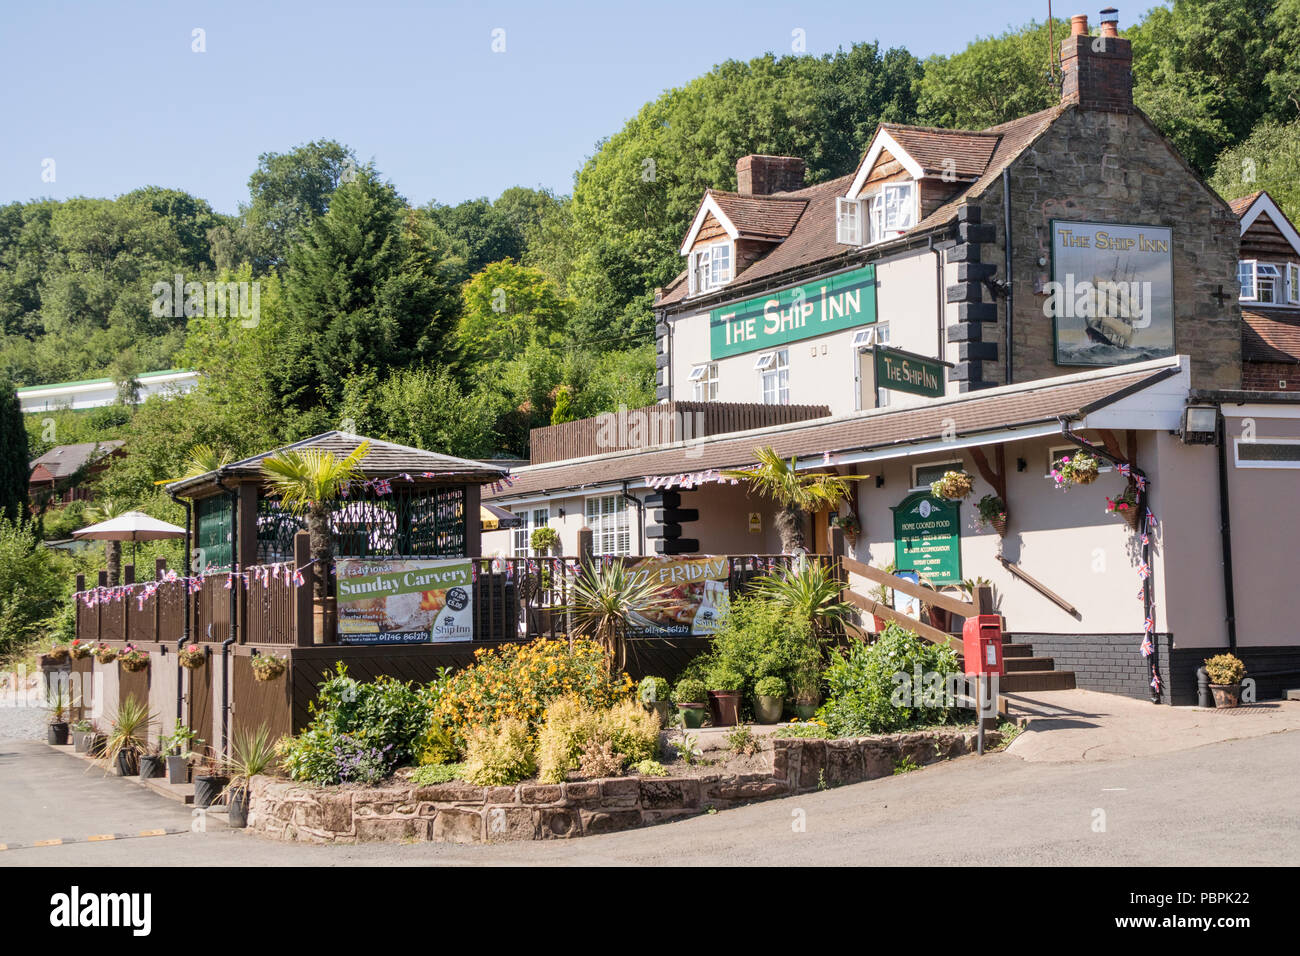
[0,731,1300,866]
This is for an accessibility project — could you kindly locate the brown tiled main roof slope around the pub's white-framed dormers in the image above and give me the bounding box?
[657,105,1073,307]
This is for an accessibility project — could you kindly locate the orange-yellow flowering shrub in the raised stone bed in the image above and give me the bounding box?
[434,640,632,750]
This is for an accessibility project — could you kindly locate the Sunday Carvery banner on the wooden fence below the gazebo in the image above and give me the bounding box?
[334,558,475,644]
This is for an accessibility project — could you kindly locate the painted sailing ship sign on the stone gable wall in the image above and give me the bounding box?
[1043,220,1174,365]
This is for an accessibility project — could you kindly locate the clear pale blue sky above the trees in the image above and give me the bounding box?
[0,0,1118,212]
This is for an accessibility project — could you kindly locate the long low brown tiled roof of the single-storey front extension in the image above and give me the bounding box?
[484,364,1177,498]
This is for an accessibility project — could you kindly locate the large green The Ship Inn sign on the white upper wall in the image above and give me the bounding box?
[709,265,876,359]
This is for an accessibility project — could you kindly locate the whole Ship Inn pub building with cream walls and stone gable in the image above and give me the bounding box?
[484,9,1300,704]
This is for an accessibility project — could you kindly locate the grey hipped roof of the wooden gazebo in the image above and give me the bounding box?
[168,431,507,497]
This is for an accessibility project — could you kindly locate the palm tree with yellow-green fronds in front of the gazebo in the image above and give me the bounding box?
[261,441,371,604]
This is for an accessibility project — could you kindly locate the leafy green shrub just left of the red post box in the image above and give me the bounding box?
[819,623,957,737]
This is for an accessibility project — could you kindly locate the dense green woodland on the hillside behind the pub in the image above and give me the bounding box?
[0,0,1300,535]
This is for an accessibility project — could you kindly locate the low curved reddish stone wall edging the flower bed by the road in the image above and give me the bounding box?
[248,731,998,843]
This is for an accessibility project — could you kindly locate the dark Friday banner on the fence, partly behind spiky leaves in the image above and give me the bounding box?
[627,555,729,637]
